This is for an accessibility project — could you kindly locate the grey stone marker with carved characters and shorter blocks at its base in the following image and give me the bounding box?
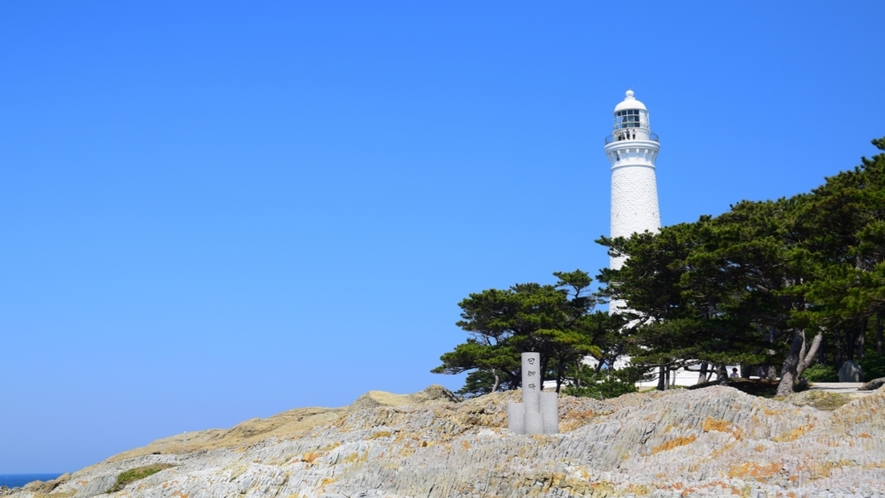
[507,353,559,434]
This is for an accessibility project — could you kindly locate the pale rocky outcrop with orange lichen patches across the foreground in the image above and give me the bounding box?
[8,386,885,498]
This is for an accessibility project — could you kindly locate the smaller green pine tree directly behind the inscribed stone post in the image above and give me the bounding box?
[432,270,625,397]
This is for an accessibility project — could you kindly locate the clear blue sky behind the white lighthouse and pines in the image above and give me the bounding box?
[0,1,885,474]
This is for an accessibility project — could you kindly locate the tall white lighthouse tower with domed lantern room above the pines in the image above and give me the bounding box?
[605,90,661,268]
